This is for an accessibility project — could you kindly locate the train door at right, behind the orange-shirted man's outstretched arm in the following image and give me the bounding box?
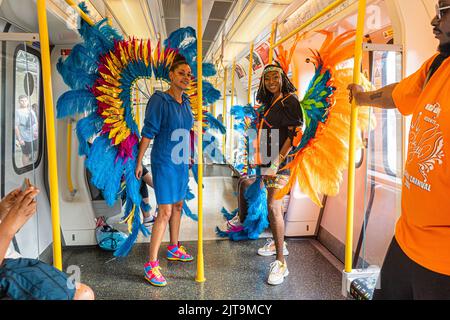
[354,43,403,268]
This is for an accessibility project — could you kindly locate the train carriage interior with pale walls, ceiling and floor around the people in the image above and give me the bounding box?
[0,0,437,300]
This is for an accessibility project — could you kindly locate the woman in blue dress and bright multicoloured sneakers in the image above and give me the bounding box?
[135,54,194,286]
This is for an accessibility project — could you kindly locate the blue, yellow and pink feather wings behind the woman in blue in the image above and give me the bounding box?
[57,3,225,256]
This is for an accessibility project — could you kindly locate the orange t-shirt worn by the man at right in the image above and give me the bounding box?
[392,55,450,275]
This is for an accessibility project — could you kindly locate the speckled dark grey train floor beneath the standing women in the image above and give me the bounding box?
[63,239,344,300]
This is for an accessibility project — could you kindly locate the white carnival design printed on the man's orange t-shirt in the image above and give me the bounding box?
[405,103,444,191]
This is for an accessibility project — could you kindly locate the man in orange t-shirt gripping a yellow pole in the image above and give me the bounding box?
[349,0,450,299]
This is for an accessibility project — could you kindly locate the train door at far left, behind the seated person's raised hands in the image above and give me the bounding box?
[1,28,52,260]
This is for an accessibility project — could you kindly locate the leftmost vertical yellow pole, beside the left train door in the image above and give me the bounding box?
[37,0,62,270]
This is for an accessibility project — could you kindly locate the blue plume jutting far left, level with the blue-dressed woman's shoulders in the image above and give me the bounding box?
[56,90,97,119]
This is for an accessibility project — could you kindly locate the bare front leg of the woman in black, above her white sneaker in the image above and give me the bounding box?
[267,188,285,263]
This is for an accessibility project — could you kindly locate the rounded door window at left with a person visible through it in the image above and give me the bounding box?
[13,45,42,174]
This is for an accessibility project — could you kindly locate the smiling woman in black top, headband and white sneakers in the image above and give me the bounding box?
[256,64,303,285]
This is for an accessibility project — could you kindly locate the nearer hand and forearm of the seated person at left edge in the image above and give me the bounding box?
[2,186,39,235]
